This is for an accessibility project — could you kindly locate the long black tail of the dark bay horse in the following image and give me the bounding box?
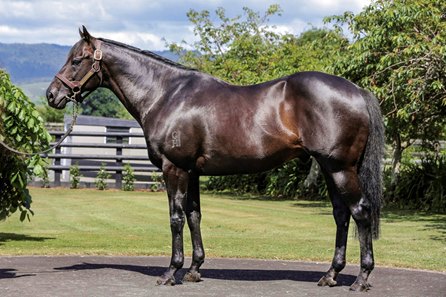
[359,90,385,238]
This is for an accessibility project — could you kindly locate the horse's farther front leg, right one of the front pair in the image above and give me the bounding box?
[183,175,204,282]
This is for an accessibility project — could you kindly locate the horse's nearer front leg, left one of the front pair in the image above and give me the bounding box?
[157,160,189,285]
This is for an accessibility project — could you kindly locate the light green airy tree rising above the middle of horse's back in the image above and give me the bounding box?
[170,5,299,85]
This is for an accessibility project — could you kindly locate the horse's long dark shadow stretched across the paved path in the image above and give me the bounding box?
[55,263,356,286]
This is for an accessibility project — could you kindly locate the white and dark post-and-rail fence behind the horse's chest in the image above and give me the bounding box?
[32,116,161,188]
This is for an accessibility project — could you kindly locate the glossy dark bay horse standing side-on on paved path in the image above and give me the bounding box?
[47,27,384,291]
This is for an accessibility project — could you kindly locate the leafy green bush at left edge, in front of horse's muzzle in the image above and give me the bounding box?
[0,70,51,221]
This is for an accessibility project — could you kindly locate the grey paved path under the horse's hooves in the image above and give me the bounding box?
[0,256,446,297]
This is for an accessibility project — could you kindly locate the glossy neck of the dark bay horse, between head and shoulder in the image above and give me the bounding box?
[104,44,186,123]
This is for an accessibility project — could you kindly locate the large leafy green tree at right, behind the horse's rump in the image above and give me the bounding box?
[326,0,446,182]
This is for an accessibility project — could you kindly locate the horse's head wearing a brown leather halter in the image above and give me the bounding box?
[46,26,103,109]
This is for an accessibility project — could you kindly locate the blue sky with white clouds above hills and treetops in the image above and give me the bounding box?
[0,0,371,50]
